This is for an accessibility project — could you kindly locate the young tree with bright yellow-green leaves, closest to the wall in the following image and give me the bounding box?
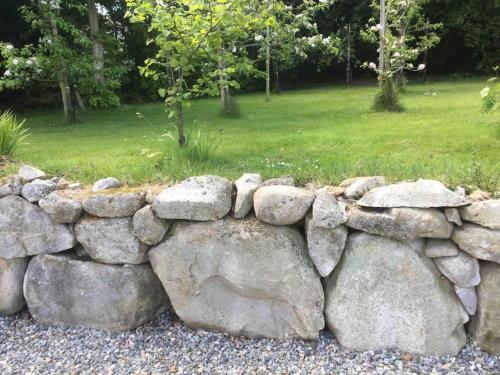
[127,0,266,146]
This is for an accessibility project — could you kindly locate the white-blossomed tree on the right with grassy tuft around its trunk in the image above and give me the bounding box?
[362,0,440,111]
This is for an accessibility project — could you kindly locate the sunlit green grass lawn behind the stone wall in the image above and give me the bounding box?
[0,78,500,190]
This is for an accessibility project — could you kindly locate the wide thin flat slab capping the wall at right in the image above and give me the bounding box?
[358,180,469,208]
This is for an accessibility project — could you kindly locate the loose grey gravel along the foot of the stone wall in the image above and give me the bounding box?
[0,312,500,375]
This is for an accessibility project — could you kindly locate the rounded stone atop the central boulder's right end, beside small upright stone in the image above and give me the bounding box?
[253,185,315,225]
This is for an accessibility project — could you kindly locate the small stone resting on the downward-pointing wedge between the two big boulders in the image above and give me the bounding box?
[312,191,348,229]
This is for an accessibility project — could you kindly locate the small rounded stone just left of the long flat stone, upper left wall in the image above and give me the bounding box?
[38,190,83,223]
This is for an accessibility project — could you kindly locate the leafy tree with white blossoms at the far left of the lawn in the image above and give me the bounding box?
[0,0,124,122]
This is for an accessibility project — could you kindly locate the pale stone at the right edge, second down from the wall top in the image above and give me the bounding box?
[451,223,500,263]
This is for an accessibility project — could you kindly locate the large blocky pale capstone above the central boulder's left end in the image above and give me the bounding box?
[153,176,233,221]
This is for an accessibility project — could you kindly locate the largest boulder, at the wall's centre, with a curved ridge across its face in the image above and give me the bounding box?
[149,218,324,339]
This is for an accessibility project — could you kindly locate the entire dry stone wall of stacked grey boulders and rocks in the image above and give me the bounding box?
[0,165,500,355]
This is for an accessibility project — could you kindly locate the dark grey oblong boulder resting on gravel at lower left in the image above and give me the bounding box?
[24,255,167,331]
